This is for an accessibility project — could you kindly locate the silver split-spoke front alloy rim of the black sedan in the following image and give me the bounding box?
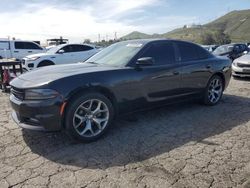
[73,99,109,138]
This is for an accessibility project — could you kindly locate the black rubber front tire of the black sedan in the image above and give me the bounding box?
[65,92,114,142]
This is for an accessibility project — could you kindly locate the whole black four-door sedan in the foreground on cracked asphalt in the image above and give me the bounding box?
[10,39,231,141]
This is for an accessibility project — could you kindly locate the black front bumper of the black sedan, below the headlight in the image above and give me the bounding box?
[10,94,62,131]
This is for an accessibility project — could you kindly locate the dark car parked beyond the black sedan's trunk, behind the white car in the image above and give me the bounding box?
[213,44,249,60]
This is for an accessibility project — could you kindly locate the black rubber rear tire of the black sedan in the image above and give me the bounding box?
[203,75,224,106]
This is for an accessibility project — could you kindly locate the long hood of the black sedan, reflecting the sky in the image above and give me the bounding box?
[10,63,118,88]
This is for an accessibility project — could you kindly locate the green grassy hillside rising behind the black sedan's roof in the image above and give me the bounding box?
[121,9,250,42]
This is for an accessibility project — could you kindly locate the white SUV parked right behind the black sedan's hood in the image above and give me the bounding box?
[22,44,100,71]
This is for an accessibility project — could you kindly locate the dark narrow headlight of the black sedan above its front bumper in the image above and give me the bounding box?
[25,89,59,100]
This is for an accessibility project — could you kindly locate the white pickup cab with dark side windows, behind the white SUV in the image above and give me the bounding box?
[12,41,44,59]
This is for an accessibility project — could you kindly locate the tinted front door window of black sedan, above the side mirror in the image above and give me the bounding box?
[141,43,175,65]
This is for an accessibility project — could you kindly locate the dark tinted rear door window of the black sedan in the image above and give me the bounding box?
[177,42,211,61]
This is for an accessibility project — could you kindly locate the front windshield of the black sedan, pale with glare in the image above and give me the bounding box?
[86,41,143,66]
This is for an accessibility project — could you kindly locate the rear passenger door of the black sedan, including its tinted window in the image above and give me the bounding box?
[175,41,213,95]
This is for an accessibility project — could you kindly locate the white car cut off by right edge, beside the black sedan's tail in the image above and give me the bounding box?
[232,54,250,77]
